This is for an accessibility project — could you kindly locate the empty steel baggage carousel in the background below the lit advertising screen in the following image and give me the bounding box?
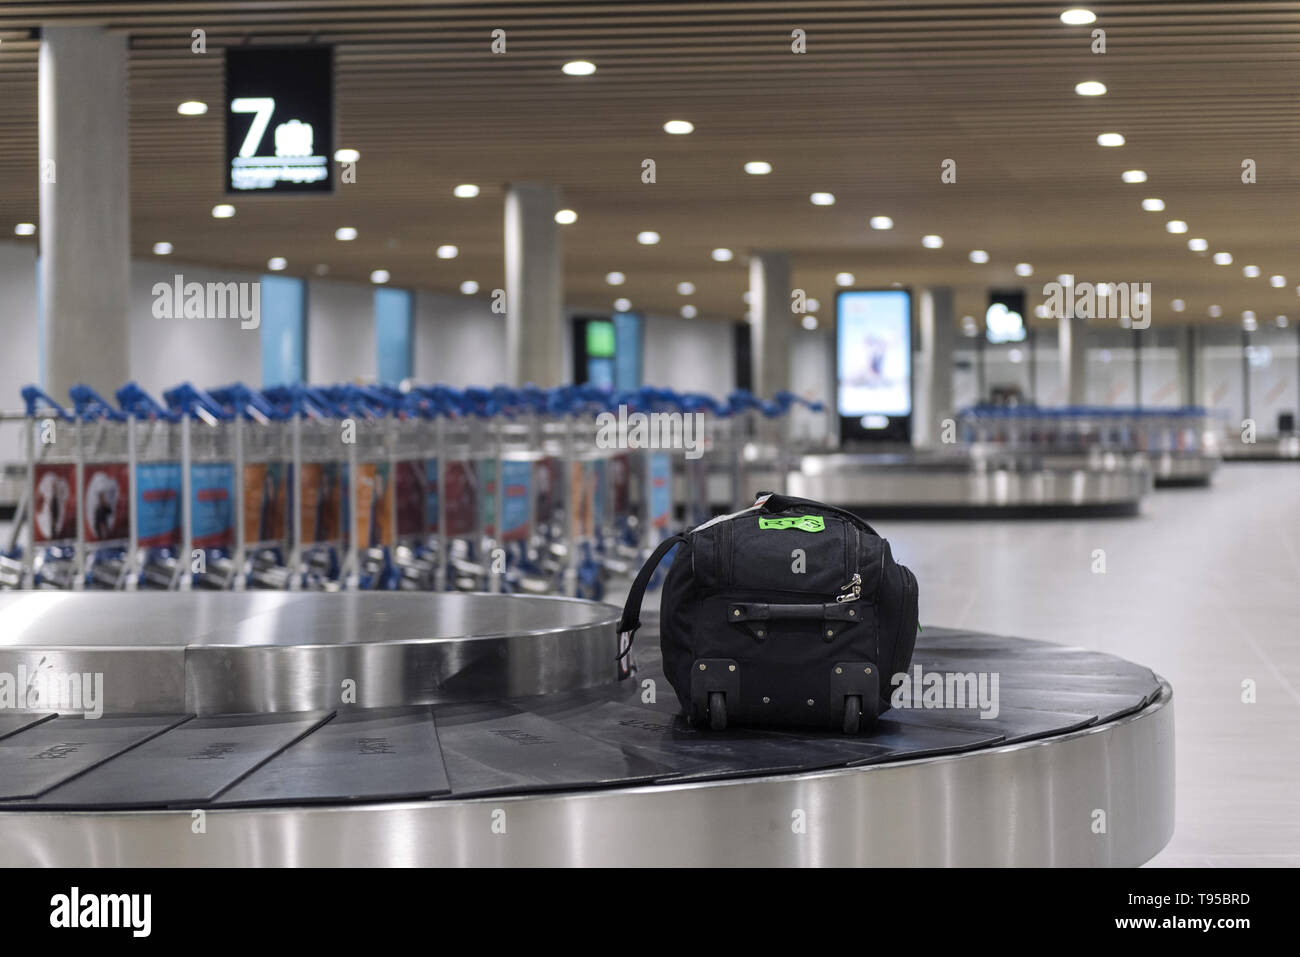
[769,451,1151,519]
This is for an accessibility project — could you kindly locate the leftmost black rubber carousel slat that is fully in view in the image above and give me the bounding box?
[27,711,332,809]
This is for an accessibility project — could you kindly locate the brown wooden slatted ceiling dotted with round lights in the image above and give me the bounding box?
[0,0,1300,324]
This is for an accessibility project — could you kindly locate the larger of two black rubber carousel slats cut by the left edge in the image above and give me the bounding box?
[0,715,190,801]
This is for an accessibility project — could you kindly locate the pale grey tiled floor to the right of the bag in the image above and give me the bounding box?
[875,463,1300,866]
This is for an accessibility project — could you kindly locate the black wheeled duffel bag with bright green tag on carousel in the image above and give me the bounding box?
[619,494,917,733]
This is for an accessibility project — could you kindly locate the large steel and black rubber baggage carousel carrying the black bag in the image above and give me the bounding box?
[0,593,1174,867]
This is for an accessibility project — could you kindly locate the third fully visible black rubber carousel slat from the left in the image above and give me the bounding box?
[437,705,671,797]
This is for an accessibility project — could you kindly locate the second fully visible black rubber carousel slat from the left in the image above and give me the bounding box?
[215,707,451,805]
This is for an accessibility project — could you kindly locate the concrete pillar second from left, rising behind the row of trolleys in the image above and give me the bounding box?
[506,183,571,387]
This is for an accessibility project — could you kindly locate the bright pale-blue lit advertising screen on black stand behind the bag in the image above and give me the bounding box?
[836,289,911,418]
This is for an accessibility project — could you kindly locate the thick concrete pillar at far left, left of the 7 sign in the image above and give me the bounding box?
[38,26,131,398]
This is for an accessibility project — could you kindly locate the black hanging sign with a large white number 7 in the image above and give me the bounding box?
[226,47,334,195]
